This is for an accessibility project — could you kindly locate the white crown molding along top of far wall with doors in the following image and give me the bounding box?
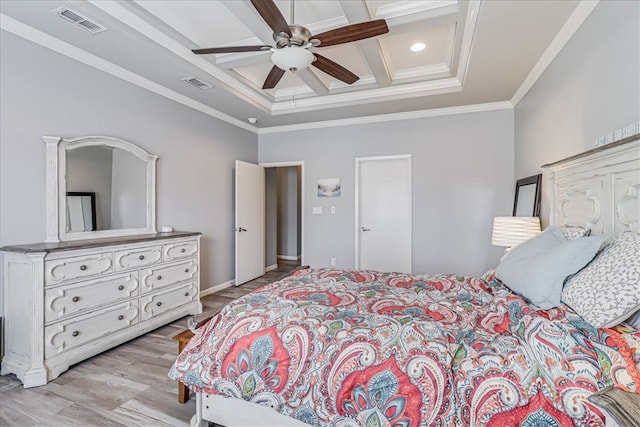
[258,101,513,135]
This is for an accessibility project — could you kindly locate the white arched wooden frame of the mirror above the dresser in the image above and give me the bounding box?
[42,136,158,242]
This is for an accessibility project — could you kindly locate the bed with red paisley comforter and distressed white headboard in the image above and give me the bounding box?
[170,140,640,426]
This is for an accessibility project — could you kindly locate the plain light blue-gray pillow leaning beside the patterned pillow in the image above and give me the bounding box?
[496,226,603,310]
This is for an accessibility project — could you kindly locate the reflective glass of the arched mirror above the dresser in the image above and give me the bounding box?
[65,146,147,232]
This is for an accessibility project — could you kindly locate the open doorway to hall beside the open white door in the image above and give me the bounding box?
[261,162,304,271]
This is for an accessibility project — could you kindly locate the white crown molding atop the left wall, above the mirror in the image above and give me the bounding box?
[0,13,258,133]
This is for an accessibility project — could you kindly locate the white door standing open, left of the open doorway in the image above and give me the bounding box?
[235,160,265,286]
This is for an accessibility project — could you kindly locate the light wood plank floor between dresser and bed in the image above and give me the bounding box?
[0,261,299,427]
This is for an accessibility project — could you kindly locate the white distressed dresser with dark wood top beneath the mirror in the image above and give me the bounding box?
[0,232,202,387]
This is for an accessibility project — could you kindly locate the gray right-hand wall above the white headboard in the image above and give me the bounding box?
[515,0,640,226]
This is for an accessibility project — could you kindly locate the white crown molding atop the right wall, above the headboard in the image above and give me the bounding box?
[511,0,600,106]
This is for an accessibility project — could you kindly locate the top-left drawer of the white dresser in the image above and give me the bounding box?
[44,252,113,285]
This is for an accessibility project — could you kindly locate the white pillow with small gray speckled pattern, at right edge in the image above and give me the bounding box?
[562,232,640,328]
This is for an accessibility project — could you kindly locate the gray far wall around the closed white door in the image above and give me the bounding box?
[259,110,514,274]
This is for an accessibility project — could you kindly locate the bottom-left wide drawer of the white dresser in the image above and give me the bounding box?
[44,301,139,358]
